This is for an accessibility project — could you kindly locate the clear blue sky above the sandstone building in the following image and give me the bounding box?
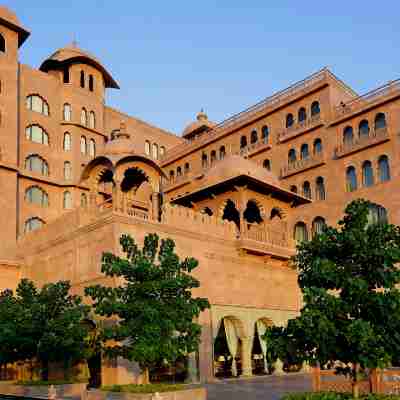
[2,0,400,133]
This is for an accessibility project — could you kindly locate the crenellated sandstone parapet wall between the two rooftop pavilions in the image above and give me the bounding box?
[161,204,237,240]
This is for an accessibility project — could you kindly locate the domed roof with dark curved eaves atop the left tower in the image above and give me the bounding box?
[39,44,119,89]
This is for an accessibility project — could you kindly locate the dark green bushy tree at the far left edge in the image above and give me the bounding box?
[0,279,90,380]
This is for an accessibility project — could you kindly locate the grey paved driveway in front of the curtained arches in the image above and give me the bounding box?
[206,374,311,400]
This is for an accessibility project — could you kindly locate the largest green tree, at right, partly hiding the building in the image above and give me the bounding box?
[266,200,400,397]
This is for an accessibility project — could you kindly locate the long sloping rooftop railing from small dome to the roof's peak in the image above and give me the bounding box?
[161,68,330,163]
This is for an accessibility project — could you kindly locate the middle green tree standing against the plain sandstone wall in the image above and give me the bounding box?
[86,234,209,381]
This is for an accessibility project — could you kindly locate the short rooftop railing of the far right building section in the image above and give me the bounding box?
[334,79,400,122]
